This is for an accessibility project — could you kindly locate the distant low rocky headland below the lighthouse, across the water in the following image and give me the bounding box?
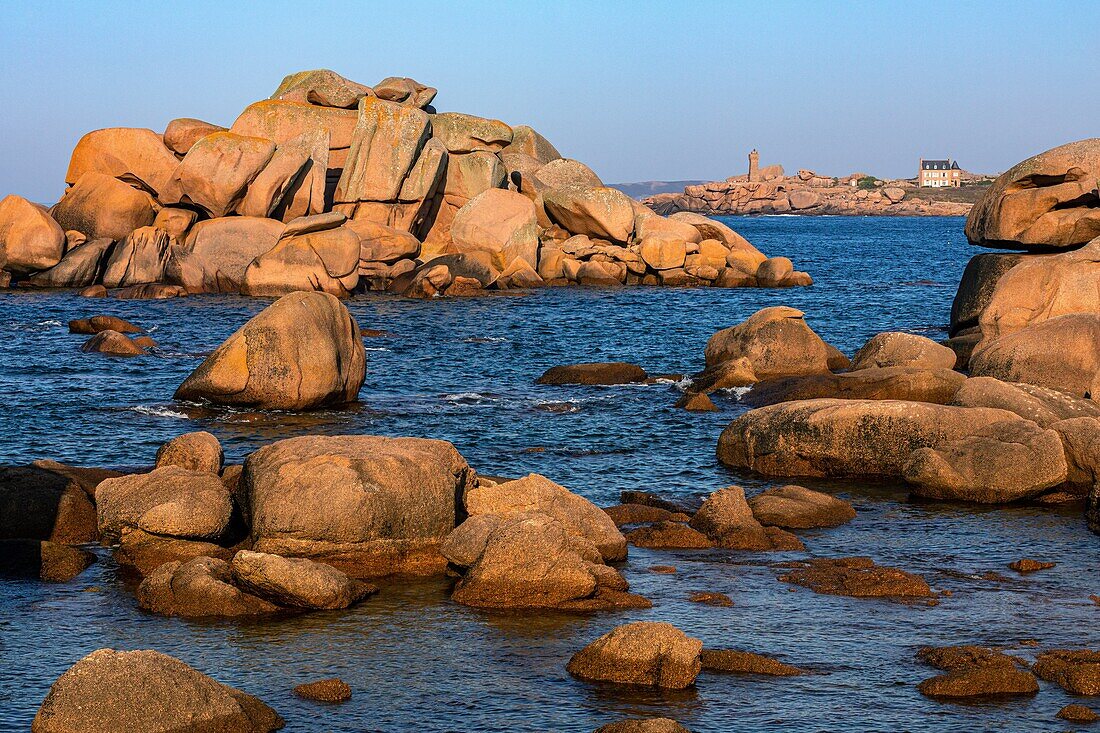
[642,165,970,217]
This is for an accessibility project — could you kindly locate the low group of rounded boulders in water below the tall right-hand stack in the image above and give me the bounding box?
[688,307,1100,503]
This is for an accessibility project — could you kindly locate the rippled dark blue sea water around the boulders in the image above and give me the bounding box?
[0,217,1100,732]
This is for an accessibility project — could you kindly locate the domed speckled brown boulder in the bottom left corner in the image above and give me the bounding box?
[31,649,283,733]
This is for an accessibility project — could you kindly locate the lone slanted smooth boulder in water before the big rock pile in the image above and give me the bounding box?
[175,293,366,409]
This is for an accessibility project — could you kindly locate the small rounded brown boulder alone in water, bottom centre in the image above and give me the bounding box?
[565,622,703,690]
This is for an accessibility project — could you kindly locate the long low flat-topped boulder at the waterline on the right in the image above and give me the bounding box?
[718,400,1021,478]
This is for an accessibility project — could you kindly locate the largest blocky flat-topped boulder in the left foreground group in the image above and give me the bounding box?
[241,436,470,578]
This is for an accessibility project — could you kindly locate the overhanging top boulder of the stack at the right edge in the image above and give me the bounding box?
[966,138,1100,251]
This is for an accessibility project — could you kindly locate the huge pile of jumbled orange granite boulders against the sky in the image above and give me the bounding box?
[0,70,811,297]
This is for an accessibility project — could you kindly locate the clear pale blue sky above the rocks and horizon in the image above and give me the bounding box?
[0,0,1100,201]
